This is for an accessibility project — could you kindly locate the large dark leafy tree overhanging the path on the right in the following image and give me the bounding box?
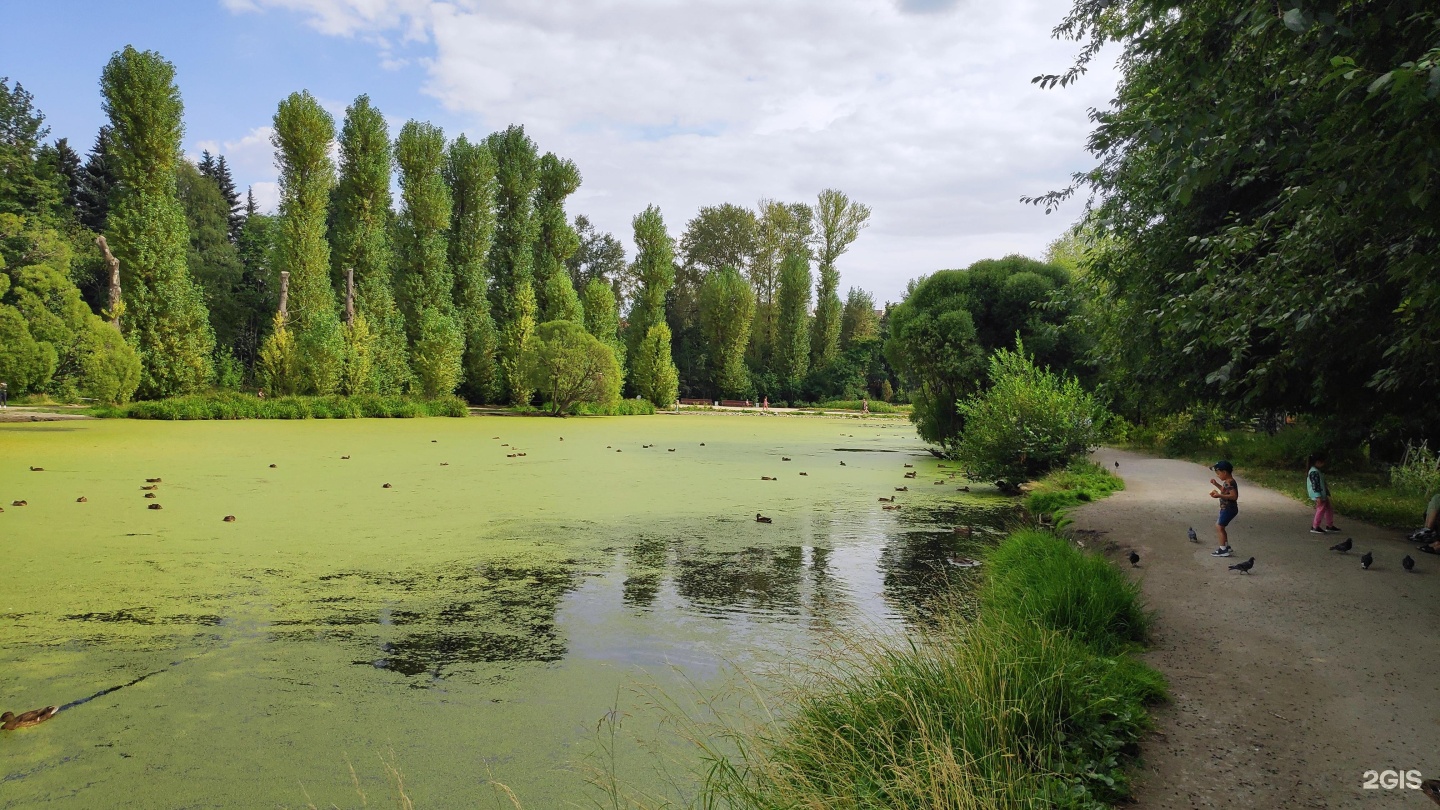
[1035,0,1440,442]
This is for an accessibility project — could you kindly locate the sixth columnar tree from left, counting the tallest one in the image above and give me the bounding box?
[485,125,540,405]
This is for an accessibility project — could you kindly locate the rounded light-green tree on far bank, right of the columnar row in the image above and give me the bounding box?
[521,320,621,417]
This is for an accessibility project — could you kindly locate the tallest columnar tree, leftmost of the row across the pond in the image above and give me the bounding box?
[99,46,215,396]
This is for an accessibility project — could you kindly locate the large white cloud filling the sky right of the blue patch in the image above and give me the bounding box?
[225,0,1115,300]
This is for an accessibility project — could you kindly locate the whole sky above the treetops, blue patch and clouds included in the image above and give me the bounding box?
[0,0,1116,301]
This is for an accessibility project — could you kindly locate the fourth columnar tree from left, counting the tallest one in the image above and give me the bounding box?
[395,121,465,396]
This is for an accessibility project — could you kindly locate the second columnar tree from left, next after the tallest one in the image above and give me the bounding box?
[271,91,344,395]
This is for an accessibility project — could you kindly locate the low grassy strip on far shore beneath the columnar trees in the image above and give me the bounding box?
[89,392,469,419]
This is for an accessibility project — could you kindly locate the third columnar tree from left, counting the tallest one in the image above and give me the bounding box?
[330,95,412,393]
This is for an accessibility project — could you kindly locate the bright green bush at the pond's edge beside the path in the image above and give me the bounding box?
[955,342,1109,484]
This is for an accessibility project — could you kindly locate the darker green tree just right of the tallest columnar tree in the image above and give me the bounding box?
[176,160,246,362]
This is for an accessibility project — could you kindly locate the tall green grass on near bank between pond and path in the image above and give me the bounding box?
[694,530,1165,809]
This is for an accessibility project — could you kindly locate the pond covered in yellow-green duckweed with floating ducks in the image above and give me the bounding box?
[0,414,1007,809]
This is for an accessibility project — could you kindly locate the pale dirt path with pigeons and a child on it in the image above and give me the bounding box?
[1074,450,1440,810]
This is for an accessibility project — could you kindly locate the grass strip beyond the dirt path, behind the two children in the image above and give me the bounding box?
[1126,425,1428,529]
